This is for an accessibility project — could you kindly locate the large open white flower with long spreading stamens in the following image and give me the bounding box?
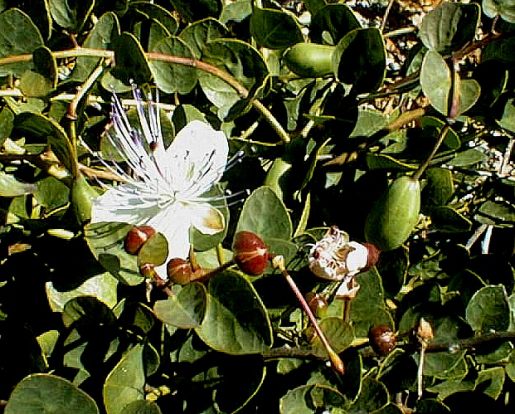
[91,87,229,268]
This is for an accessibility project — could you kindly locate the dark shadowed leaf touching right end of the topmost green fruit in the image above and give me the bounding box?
[333,28,386,94]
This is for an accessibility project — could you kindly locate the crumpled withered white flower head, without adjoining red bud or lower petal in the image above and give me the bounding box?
[308,226,368,282]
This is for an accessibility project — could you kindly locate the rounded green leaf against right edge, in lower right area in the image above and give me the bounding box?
[466,285,511,334]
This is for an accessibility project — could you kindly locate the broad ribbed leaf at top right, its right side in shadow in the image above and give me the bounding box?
[420,2,480,54]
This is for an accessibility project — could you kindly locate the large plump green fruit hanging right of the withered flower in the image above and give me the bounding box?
[365,176,420,251]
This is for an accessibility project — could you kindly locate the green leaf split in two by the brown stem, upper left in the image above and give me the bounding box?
[71,12,120,82]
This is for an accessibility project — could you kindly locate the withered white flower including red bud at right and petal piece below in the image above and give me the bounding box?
[308,226,379,297]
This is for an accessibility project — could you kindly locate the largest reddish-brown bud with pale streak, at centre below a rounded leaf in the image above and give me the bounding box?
[232,231,270,276]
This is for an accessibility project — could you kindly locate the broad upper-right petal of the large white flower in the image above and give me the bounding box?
[160,121,229,201]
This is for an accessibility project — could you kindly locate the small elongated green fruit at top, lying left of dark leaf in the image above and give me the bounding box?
[284,43,335,78]
